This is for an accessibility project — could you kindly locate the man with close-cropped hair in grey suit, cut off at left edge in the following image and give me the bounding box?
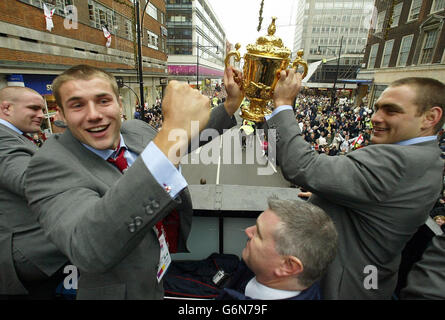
[0,87,68,299]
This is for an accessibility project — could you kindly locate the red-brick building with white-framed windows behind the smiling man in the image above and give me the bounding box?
[0,0,168,129]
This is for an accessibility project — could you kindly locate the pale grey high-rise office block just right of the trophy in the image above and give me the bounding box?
[293,0,374,89]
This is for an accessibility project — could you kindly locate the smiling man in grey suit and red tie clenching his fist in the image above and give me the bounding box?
[26,65,242,299]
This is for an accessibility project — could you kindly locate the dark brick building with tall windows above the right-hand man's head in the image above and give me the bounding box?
[358,0,445,105]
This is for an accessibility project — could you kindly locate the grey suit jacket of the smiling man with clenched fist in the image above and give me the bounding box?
[26,107,236,299]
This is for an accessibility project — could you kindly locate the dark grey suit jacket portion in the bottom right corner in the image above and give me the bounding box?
[400,234,445,300]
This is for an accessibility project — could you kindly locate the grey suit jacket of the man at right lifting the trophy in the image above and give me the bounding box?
[268,110,443,299]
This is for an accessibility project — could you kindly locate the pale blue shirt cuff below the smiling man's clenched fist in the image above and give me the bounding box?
[141,141,187,198]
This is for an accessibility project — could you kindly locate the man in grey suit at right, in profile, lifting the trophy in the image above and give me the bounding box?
[267,70,445,299]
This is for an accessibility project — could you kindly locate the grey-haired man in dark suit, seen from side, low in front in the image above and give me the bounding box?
[219,198,337,300]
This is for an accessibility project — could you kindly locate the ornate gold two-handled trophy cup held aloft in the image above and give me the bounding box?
[225,17,308,122]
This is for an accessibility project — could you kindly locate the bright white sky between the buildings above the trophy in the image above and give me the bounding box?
[207,0,300,55]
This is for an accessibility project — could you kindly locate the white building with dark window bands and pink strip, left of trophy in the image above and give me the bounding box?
[167,0,226,90]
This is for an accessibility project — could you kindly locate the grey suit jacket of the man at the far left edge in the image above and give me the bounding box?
[0,124,68,295]
